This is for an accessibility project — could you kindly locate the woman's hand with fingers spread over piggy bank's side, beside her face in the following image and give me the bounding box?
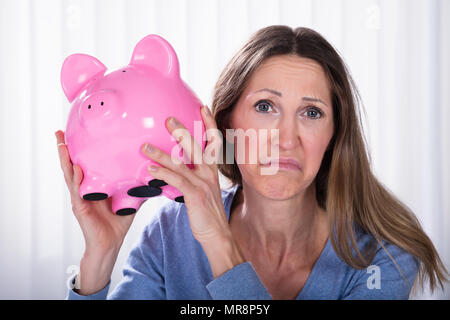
[142,106,243,278]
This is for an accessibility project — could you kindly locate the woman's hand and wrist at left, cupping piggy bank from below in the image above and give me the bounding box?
[55,130,135,295]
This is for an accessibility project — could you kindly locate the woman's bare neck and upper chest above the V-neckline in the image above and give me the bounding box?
[230,183,328,268]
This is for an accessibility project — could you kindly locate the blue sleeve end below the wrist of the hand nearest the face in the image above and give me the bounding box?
[206,262,272,300]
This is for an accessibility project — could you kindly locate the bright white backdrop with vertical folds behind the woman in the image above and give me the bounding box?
[0,0,450,299]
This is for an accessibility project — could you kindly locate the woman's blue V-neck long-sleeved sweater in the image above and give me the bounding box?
[67,185,419,300]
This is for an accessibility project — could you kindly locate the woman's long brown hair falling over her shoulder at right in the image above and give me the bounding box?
[212,26,448,290]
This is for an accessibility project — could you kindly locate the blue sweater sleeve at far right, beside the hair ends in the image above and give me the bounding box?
[343,244,419,300]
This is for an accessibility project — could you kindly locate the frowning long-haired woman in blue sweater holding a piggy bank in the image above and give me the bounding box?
[56,26,446,299]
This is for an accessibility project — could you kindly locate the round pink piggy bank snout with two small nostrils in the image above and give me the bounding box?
[79,91,118,126]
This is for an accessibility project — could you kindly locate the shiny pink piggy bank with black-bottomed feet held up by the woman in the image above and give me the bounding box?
[61,35,206,215]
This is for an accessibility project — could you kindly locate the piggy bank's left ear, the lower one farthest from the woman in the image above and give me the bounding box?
[61,54,106,102]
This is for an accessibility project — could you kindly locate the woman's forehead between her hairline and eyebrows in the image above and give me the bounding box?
[246,55,330,100]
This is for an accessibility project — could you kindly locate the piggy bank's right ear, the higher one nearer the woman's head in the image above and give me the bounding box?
[130,34,180,77]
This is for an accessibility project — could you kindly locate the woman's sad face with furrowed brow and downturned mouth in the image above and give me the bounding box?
[230,55,334,200]
